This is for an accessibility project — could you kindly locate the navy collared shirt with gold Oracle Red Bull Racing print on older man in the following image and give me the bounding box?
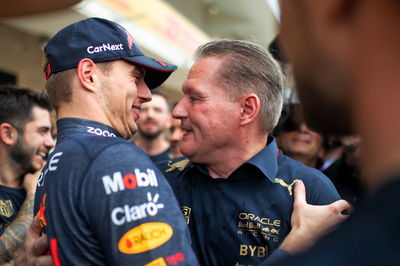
[158,137,340,266]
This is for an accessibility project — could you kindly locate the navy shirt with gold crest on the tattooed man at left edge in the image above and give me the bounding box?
[0,186,26,235]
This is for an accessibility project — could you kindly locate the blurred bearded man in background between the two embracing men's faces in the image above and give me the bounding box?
[135,92,171,163]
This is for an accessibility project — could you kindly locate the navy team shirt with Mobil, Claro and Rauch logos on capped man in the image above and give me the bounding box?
[35,118,197,265]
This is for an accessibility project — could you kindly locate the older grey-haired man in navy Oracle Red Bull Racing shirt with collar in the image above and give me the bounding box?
[159,40,339,265]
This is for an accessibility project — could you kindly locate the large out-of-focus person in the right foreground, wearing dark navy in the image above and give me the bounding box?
[260,0,400,266]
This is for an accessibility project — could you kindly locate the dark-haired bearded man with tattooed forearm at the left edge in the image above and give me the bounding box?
[0,85,54,263]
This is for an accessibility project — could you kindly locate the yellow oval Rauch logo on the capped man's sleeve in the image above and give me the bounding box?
[118,222,174,254]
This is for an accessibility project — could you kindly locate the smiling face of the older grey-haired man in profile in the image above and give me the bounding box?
[172,57,240,163]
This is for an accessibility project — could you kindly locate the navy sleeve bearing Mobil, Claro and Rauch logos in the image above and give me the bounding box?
[80,144,197,265]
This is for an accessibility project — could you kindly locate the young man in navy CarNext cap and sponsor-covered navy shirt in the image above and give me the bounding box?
[35,18,197,265]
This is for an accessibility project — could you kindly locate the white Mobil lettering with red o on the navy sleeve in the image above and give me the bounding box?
[101,168,158,195]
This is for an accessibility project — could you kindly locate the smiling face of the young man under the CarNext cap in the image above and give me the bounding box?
[101,60,151,139]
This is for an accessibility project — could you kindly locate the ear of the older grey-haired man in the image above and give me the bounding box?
[240,93,261,126]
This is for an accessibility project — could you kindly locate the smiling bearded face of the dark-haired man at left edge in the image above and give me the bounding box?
[10,106,54,173]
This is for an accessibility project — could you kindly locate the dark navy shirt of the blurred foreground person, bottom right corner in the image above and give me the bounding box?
[262,177,400,266]
